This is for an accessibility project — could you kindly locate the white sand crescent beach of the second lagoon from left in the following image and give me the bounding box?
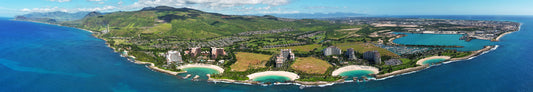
[247,71,300,80]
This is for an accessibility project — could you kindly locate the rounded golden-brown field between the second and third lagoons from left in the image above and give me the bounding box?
[291,57,332,74]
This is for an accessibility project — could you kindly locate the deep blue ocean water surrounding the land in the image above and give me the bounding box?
[0,16,533,92]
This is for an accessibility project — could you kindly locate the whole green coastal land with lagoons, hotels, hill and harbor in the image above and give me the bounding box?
[15,6,521,86]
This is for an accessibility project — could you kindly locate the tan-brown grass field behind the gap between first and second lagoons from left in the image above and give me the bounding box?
[230,52,272,71]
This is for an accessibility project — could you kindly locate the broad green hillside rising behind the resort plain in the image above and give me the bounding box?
[63,6,329,39]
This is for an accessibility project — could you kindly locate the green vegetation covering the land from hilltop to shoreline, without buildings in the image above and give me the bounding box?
[14,6,516,85]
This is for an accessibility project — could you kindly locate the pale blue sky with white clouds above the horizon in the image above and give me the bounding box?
[0,0,533,17]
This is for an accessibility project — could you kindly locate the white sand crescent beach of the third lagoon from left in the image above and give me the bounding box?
[331,65,379,76]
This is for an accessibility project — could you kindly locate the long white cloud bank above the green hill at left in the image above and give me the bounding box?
[20,0,299,14]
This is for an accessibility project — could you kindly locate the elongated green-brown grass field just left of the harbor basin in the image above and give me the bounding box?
[334,42,399,57]
